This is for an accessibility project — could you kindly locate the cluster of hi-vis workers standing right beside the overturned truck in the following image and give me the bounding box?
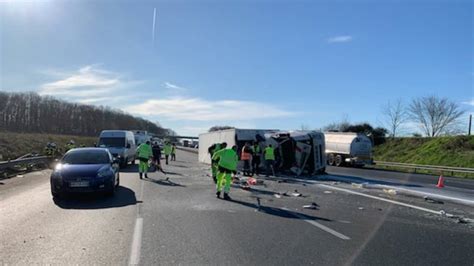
[208,141,275,200]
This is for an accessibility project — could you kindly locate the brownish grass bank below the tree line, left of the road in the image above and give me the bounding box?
[0,131,97,161]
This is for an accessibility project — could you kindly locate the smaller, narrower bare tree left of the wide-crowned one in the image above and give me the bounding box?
[382,99,408,137]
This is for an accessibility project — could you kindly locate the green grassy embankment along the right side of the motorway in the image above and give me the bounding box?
[374,136,474,168]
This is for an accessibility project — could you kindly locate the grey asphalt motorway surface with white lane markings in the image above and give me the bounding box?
[0,151,474,265]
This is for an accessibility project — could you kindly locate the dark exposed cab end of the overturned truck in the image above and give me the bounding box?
[265,131,326,176]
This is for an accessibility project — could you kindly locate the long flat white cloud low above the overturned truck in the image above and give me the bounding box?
[125,97,294,122]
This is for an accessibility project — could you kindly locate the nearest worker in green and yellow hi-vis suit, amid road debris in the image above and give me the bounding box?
[212,145,239,200]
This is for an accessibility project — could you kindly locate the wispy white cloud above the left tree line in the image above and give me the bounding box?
[38,65,142,103]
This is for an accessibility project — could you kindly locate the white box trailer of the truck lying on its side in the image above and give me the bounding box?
[199,128,277,164]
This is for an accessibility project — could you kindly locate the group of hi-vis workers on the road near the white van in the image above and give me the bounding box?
[136,140,176,179]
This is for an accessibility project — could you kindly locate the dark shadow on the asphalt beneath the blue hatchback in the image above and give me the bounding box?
[53,186,142,209]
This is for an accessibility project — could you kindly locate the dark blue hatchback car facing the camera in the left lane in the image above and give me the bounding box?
[51,148,120,198]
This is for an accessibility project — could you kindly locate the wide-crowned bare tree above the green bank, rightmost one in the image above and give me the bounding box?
[408,96,464,137]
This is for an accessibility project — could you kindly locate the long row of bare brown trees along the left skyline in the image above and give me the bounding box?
[0,92,167,136]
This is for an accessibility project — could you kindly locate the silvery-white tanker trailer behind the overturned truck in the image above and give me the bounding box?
[324,132,373,166]
